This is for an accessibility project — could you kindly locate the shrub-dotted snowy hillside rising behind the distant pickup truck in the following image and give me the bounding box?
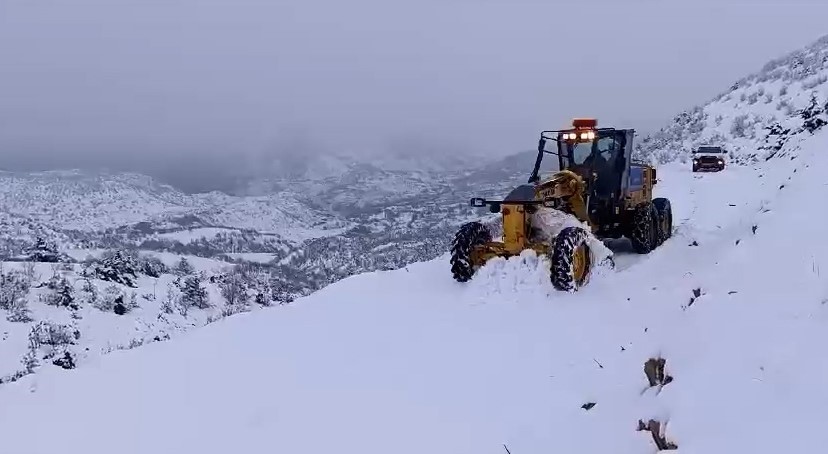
[638,36,828,163]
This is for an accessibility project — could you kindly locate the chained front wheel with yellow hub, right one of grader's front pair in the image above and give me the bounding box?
[550,227,592,292]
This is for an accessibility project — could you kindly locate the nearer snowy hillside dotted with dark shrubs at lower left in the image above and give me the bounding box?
[0,251,287,386]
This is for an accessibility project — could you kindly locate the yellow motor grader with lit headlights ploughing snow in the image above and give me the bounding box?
[450,118,673,291]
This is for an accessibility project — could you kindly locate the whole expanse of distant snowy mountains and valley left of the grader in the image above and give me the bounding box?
[0,160,529,285]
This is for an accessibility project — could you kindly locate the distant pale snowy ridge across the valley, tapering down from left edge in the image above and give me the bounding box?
[0,171,348,241]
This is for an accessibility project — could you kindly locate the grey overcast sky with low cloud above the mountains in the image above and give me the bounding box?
[0,0,828,184]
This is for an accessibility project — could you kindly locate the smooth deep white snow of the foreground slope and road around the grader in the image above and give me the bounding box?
[0,118,828,454]
